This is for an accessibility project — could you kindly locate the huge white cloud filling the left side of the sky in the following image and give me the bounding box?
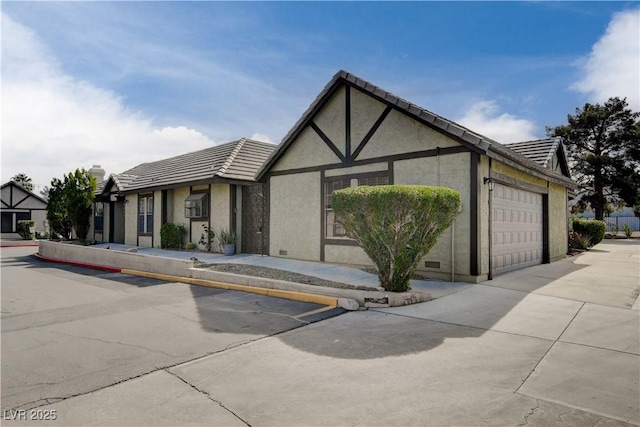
[2,14,215,191]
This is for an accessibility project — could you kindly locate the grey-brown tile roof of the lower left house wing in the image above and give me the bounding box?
[97,138,275,193]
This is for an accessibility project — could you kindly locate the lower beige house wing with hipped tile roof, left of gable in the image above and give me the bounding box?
[92,138,275,253]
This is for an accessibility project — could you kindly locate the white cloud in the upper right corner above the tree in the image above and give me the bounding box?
[572,9,640,111]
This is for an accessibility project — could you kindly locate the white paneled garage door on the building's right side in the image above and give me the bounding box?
[491,184,543,274]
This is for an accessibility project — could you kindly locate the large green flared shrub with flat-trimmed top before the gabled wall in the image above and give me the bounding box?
[331,185,460,292]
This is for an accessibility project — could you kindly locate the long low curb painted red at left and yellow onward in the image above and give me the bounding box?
[33,254,353,310]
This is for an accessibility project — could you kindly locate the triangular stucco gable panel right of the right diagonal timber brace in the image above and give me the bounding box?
[358,110,460,160]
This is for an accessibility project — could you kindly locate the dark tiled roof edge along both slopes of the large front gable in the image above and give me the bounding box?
[257,70,575,186]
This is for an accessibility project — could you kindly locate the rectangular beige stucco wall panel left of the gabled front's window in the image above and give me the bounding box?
[269,172,321,261]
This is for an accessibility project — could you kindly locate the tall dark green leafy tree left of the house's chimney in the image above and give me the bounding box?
[47,169,97,241]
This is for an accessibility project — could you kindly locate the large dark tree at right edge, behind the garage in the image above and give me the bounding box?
[547,97,640,220]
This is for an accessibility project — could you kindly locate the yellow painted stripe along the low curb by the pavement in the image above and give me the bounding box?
[120,268,338,308]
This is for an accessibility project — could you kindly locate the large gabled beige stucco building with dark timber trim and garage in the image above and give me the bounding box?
[257,71,575,282]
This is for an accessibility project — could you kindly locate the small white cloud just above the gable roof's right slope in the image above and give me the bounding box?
[456,101,538,144]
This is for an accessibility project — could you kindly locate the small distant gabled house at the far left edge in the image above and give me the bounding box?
[0,181,47,238]
